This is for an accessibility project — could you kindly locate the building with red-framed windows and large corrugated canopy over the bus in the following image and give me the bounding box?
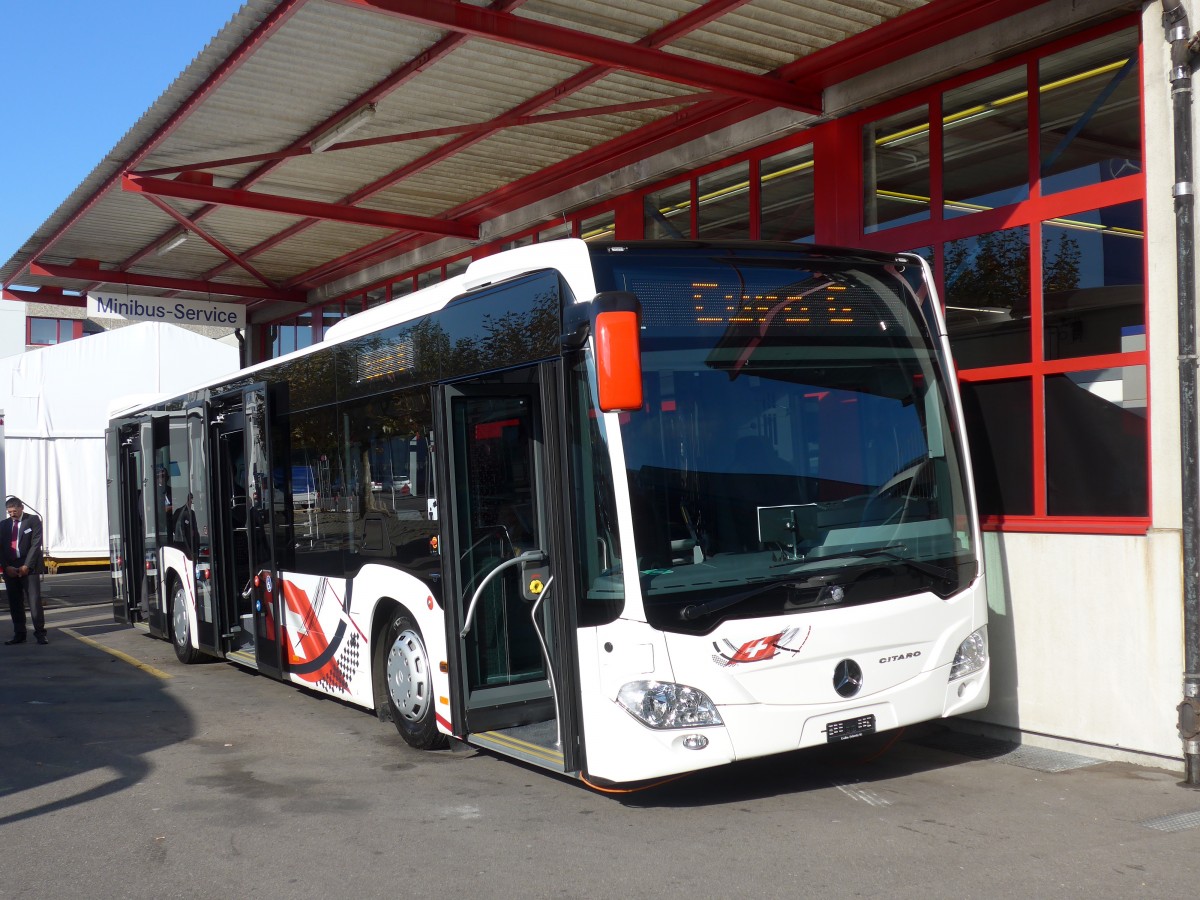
[0,0,1200,774]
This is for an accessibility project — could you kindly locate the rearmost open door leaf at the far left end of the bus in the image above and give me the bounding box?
[104,420,145,625]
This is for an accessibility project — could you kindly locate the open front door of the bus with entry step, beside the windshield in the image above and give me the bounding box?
[436,365,578,772]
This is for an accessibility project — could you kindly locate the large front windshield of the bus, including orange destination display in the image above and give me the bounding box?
[596,245,977,632]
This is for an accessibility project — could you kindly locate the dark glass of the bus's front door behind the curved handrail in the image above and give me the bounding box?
[442,379,557,744]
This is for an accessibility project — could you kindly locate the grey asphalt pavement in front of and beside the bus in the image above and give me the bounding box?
[0,572,1200,900]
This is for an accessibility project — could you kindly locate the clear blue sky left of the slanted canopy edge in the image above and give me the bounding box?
[0,0,241,271]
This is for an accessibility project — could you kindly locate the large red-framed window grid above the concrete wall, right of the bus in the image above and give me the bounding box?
[846,22,1150,533]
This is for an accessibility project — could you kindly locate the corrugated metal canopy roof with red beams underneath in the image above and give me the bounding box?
[0,0,1108,324]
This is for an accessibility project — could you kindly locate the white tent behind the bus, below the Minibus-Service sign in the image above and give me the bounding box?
[0,322,238,560]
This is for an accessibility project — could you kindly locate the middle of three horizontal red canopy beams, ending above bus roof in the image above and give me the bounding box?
[121,173,479,240]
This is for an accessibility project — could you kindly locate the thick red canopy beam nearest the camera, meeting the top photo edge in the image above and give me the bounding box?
[341,0,821,114]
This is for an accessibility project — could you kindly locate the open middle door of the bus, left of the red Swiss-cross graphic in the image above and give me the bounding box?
[209,384,283,678]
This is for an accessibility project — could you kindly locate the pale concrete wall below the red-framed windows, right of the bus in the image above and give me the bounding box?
[972,529,1183,768]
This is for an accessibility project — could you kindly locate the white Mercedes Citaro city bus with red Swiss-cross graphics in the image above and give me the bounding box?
[108,240,989,784]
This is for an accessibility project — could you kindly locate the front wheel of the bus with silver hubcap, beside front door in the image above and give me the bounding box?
[379,611,449,750]
